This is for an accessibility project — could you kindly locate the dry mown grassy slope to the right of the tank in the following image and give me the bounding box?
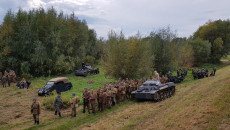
[80,66,230,129]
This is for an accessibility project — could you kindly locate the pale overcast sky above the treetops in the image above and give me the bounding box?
[0,0,230,38]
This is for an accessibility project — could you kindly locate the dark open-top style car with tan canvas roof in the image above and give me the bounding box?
[38,77,73,96]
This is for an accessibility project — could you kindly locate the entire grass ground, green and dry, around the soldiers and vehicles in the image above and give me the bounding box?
[0,62,230,130]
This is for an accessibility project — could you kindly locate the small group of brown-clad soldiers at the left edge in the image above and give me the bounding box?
[0,70,16,88]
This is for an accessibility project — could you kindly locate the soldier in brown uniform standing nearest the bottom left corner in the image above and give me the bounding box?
[30,98,41,125]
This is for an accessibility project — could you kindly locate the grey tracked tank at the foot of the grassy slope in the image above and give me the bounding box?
[131,80,175,102]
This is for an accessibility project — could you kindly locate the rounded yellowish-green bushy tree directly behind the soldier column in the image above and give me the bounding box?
[102,32,151,78]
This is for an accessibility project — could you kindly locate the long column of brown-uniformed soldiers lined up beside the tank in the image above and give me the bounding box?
[82,78,144,114]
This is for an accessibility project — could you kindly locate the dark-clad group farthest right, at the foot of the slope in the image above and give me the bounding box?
[192,67,216,79]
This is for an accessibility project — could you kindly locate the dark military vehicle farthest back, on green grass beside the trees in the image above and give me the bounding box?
[75,65,99,77]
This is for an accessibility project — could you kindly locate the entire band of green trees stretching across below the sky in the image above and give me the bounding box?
[0,8,230,78]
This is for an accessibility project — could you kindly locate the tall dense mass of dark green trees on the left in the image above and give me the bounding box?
[0,8,100,76]
